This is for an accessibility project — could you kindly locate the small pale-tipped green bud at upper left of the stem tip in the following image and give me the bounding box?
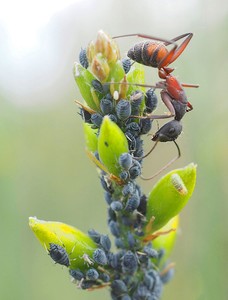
[73,62,102,111]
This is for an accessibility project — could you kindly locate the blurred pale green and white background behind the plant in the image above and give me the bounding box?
[0,0,228,300]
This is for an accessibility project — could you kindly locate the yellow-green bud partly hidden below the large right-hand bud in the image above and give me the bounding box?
[153,215,179,266]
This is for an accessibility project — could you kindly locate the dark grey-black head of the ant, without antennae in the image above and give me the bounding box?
[152,120,182,142]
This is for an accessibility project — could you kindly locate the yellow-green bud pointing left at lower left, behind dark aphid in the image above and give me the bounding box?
[29,217,96,270]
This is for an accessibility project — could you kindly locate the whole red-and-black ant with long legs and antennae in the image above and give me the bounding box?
[113,33,198,179]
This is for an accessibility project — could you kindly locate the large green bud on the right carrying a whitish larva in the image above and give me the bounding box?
[146,163,196,233]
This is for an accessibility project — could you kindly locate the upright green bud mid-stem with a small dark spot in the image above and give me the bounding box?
[98,116,129,176]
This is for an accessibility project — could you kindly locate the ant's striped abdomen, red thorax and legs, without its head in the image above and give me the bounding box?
[113,33,198,119]
